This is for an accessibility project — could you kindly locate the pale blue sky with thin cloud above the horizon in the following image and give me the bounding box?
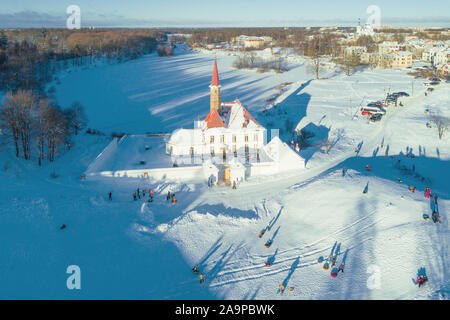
[0,0,450,28]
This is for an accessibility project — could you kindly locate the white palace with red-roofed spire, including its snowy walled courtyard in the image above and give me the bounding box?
[86,60,304,185]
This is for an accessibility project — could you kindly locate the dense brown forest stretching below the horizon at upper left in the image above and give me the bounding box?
[0,29,166,93]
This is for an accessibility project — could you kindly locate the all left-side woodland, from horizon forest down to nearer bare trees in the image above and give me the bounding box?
[0,29,166,165]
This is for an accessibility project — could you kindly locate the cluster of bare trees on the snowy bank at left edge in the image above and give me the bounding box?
[0,89,87,166]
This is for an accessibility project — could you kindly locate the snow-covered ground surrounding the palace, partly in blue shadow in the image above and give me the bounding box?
[0,48,450,299]
